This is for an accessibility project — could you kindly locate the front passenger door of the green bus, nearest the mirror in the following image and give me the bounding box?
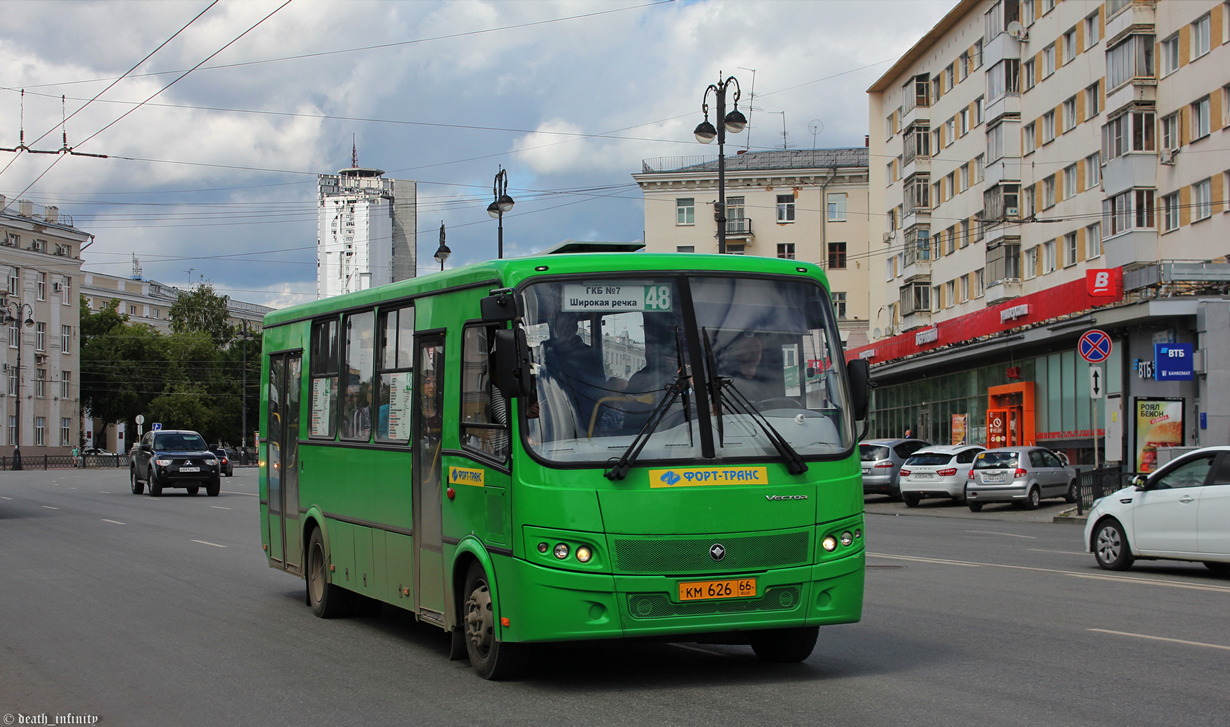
[411,333,445,622]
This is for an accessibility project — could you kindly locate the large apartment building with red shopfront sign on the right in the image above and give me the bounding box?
[865,0,1230,469]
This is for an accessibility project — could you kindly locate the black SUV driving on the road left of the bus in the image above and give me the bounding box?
[128,429,221,497]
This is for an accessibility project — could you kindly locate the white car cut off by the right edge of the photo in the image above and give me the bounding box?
[1085,447,1230,576]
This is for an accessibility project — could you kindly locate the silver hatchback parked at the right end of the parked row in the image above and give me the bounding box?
[966,447,1077,513]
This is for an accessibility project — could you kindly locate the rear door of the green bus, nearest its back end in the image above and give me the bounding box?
[264,352,303,572]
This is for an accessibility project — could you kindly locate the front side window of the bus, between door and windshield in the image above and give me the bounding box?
[460,326,509,461]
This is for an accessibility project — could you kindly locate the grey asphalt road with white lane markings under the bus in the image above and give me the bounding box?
[0,470,1230,727]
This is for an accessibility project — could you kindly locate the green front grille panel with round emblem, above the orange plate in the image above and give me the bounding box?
[614,530,811,576]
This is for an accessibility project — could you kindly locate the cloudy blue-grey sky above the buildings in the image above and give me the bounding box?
[0,0,956,308]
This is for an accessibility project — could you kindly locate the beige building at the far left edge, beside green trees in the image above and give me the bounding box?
[0,196,91,469]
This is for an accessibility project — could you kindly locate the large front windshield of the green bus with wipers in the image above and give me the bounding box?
[522,274,854,464]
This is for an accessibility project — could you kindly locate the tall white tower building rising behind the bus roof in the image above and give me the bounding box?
[316,164,416,298]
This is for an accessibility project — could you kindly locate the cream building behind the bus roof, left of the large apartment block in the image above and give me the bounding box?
[632,148,870,344]
